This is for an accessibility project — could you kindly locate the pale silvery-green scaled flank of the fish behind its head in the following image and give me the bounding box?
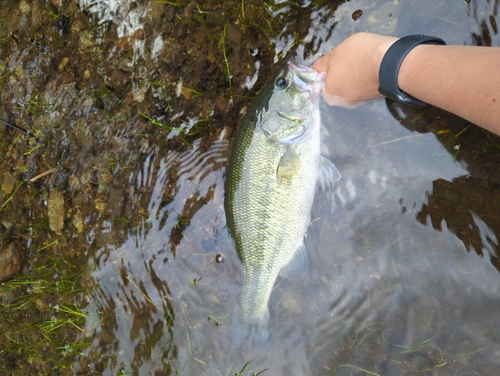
[229,126,319,284]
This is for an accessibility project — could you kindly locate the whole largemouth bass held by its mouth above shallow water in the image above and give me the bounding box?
[224,60,340,346]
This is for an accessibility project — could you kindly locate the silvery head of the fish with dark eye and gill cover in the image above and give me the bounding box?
[260,60,325,144]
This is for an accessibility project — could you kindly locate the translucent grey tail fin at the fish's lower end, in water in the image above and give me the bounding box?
[229,305,269,348]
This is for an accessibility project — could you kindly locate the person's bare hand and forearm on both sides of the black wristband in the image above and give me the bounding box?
[313,33,500,135]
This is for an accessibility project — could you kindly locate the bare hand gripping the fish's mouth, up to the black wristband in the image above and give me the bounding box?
[312,33,397,108]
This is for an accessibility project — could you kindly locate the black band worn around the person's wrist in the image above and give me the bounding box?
[378,34,446,107]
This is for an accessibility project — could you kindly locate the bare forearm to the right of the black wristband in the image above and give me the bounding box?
[398,44,500,135]
